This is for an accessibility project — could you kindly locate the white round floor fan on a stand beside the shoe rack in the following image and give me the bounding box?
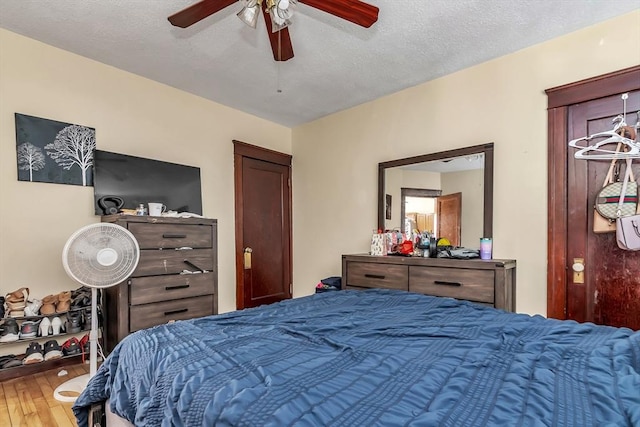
[53,223,140,402]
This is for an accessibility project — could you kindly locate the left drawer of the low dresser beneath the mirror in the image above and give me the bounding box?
[346,262,408,291]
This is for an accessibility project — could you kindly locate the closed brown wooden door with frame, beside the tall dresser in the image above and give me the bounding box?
[234,141,292,309]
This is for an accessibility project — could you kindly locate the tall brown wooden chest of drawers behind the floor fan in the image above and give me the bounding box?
[102,215,218,351]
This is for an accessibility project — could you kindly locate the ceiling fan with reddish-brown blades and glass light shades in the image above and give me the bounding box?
[168,0,379,61]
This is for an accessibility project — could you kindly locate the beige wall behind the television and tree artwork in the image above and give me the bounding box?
[0,29,291,320]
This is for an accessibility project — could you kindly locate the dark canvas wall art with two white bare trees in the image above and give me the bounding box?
[16,113,96,186]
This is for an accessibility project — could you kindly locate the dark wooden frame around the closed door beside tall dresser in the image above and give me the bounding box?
[233,139,293,310]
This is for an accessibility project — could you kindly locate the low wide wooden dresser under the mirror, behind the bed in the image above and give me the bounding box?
[342,255,516,311]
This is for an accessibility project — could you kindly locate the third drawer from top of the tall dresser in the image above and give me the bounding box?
[129,273,214,305]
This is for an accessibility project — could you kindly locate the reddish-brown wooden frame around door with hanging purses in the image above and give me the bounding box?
[545,66,640,319]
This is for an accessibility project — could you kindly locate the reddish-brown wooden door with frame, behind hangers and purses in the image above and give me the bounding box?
[547,67,640,329]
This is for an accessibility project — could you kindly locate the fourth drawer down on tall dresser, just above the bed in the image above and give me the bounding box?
[129,295,213,332]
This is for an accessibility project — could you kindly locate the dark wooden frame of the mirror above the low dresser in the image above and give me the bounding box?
[378,142,493,237]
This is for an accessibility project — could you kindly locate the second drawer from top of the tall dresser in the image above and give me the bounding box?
[131,249,214,277]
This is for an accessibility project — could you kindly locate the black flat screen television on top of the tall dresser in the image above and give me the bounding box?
[93,150,202,215]
